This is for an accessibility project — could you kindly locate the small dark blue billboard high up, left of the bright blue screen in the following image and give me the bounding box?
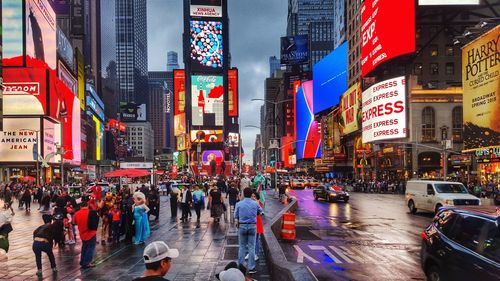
[280,35,309,65]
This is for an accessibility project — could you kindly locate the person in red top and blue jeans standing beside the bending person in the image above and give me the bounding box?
[73,200,99,269]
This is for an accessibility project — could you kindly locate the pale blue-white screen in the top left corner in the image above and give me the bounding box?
[1,0,24,66]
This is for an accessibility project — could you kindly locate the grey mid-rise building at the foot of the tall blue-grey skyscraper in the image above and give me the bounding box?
[126,122,154,161]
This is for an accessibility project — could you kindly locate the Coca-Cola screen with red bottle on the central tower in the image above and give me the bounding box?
[191,75,224,126]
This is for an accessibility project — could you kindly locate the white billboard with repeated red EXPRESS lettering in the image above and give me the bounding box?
[361,76,407,143]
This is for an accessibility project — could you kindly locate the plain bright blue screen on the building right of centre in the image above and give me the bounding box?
[313,42,347,113]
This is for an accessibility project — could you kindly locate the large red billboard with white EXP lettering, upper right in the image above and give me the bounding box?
[361,0,415,77]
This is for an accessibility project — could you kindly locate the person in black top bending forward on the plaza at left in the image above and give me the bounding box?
[33,217,64,277]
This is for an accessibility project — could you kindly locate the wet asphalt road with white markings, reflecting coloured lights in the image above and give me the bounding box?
[282,189,433,281]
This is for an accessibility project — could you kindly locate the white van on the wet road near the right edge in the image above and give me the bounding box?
[406,180,481,214]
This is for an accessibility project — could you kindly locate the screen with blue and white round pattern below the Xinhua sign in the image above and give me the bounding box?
[189,20,223,71]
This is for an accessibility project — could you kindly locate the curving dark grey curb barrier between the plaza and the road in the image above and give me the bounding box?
[262,197,318,281]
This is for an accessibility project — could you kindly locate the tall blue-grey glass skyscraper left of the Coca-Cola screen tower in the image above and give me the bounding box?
[115,0,148,104]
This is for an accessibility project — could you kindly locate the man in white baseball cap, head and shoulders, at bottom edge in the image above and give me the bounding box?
[134,238,179,281]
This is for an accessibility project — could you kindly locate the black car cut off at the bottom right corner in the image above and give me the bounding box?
[420,206,500,281]
